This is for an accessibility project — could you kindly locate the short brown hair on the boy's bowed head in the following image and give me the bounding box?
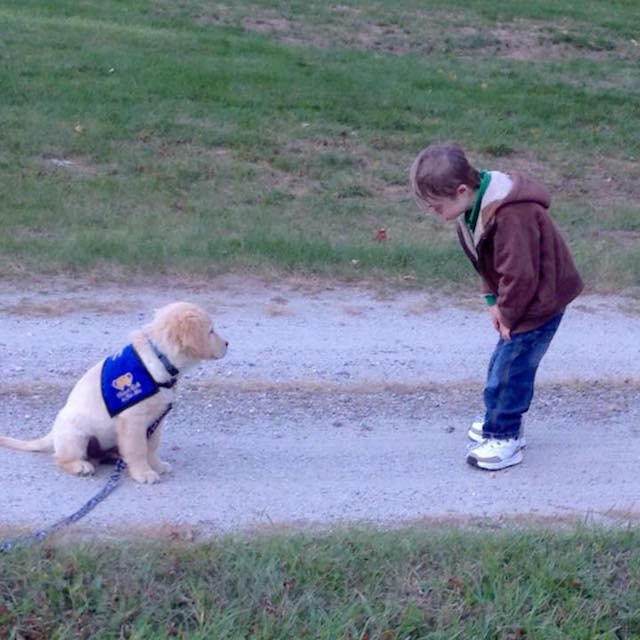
[409,142,481,202]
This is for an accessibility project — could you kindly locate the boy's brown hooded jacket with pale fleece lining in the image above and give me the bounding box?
[458,172,583,333]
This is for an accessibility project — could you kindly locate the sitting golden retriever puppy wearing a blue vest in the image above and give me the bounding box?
[0,302,228,483]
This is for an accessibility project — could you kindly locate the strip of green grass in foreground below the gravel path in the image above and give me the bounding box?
[0,528,640,640]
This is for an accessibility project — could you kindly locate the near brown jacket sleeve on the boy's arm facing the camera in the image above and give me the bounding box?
[493,203,540,328]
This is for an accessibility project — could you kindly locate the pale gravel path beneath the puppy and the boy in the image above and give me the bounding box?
[0,278,640,538]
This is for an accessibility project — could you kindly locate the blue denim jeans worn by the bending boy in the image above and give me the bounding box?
[483,312,564,438]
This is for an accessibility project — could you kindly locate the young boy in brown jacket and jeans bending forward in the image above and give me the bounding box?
[410,142,583,471]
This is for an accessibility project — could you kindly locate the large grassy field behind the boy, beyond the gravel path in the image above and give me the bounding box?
[0,0,640,291]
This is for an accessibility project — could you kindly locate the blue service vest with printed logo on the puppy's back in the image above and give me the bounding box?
[101,344,158,417]
